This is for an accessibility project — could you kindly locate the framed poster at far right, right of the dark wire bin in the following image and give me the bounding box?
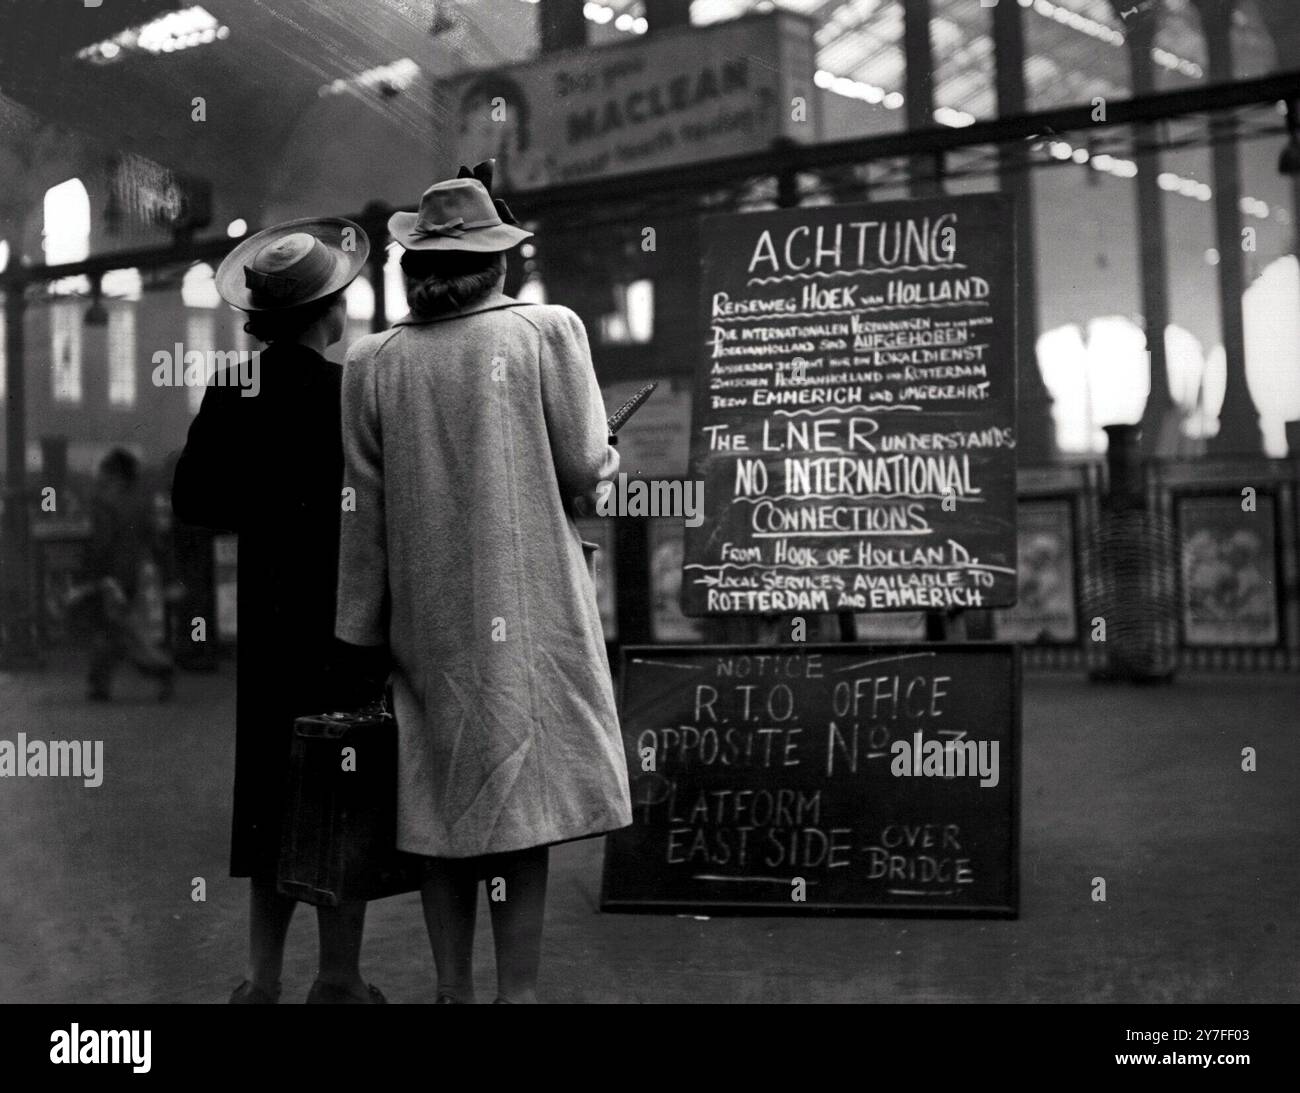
[1174,493,1281,646]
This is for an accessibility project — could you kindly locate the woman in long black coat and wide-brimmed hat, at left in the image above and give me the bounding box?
[172,220,384,1003]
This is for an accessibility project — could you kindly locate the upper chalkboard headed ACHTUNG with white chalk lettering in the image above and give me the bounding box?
[683,195,1017,615]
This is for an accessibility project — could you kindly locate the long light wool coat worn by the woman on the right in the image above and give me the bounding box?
[335,294,632,858]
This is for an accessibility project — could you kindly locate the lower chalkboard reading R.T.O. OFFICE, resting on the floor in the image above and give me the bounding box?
[601,643,1019,916]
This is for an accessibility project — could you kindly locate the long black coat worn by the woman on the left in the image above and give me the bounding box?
[172,346,377,877]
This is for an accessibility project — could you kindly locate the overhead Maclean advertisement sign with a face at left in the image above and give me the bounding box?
[434,12,819,191]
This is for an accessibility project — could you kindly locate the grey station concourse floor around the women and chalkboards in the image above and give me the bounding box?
[0,652,1300,1002]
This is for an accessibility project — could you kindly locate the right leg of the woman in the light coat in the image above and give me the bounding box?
[488,846,550,1002]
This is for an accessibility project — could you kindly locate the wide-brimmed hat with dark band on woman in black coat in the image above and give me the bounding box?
[216,217,371,312]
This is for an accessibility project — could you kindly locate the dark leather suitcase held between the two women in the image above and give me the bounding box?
[278,710,426,907]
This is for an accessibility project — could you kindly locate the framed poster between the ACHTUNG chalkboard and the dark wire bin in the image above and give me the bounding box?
[996,498,1079,645]
